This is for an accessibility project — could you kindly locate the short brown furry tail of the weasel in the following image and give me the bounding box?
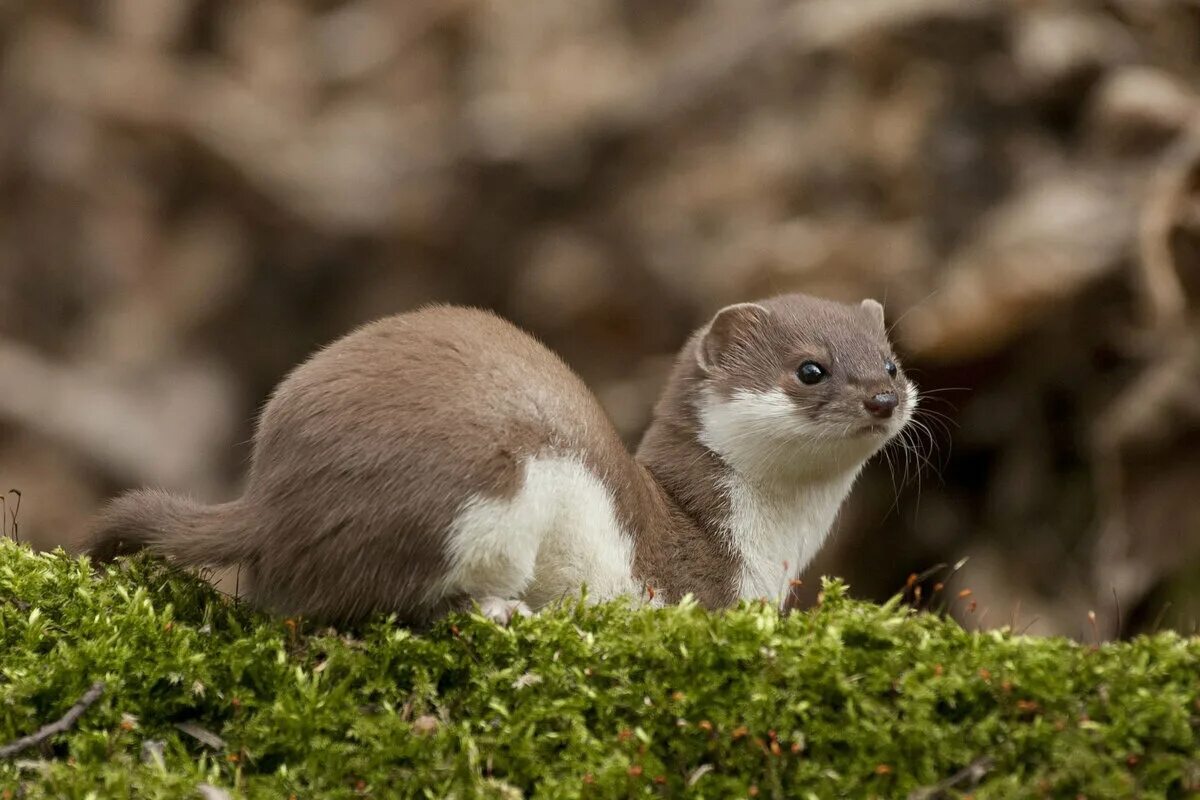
[88,489,253,566]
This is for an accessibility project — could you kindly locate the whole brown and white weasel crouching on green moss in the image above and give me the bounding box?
[90,294,917,624]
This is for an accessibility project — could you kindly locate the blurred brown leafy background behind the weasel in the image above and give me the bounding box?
[0,0,1200,640]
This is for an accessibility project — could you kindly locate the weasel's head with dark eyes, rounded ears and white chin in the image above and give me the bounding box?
[690,294,917,473]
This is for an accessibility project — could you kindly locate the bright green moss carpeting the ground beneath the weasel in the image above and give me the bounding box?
[0,542,1200,798]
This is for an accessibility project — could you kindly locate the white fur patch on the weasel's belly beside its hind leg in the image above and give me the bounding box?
[434,457,640,609]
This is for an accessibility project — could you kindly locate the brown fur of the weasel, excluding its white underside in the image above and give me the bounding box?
[91,295,907,621]
